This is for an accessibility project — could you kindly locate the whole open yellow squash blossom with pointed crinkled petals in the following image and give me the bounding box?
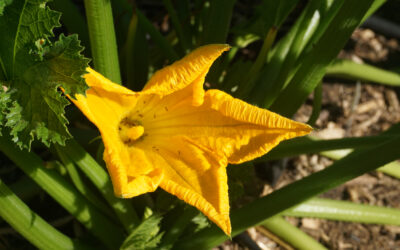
[72,45,311,235]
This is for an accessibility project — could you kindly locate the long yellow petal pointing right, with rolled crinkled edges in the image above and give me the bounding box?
[143,86,312,166]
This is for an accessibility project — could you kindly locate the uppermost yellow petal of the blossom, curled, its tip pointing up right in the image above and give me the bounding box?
[143,44,229,104]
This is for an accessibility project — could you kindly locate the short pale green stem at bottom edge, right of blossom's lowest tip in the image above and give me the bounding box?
[261,215,326,250]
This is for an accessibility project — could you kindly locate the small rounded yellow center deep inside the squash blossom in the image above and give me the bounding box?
[118,118,144,146]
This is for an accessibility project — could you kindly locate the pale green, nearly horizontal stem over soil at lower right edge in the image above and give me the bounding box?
[282,198,400,226]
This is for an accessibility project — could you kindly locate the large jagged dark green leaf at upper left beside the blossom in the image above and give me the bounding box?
[0,0,89,148]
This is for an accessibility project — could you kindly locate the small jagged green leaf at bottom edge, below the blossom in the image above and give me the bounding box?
[120,215,163,250]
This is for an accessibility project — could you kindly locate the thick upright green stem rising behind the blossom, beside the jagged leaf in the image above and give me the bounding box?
[84,0,121,84]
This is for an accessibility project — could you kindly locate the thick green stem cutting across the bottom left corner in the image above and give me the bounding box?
[0,180,83,249]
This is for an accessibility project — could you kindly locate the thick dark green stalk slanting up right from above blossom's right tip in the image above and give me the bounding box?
[271,0,373,117]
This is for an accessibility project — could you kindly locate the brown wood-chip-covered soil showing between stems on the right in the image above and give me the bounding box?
[216,28,400,250]
